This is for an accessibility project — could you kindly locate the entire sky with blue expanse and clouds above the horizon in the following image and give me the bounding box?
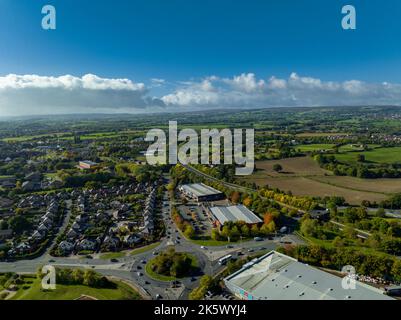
[0,0,401,116]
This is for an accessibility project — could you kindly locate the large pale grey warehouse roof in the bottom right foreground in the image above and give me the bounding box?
[224,251,393,300]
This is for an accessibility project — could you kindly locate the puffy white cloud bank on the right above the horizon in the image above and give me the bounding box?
[161,73,401,108]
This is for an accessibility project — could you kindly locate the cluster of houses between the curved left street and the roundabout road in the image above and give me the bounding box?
[58,183,156,255]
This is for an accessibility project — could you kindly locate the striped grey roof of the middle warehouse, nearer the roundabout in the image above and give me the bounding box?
[210,205,262,224]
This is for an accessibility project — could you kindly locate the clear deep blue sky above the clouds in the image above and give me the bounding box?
[0,0,401,113]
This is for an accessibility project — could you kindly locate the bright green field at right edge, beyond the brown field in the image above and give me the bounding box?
[335,147,401,164]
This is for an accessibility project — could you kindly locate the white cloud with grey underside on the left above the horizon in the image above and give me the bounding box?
[0,74,163,115]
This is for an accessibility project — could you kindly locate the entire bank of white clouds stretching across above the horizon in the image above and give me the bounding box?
[0,73,401,115]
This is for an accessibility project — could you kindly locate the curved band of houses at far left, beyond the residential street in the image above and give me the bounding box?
[7,194,60,256]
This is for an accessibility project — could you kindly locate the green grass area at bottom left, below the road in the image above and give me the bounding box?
[12,278,141,300]
